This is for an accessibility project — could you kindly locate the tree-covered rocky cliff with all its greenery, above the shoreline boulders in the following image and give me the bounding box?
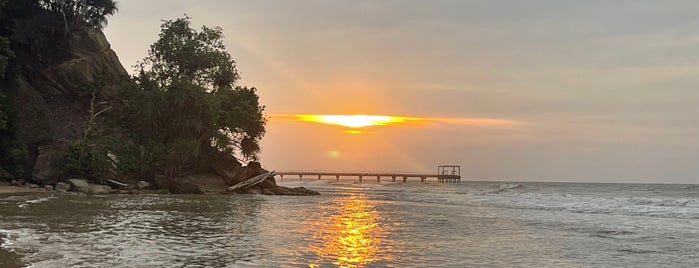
[0,0,265,183]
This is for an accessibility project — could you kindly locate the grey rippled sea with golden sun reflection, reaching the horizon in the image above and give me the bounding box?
[0,178,699,267]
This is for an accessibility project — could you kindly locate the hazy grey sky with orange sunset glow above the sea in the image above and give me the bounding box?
[105,0,699,183]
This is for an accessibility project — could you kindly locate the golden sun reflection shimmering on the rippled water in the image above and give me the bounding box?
[308,194,390,267]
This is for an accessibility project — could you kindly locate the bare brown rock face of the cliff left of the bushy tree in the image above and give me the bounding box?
[14,28,128,184]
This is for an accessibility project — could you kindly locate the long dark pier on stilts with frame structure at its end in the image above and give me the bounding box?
[276,166,461,183]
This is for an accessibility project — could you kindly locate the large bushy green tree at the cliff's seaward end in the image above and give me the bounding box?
[111,17,266,177]
